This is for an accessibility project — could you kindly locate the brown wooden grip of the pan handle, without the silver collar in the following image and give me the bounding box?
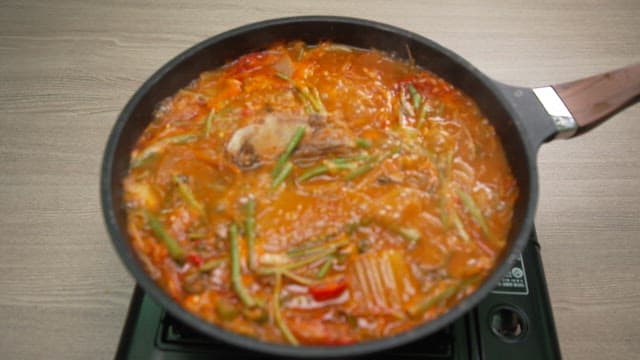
[552,63,640,135]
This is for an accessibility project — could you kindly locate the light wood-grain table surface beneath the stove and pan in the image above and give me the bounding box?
[0,0,640,359]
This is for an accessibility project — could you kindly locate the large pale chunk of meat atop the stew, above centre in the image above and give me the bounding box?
[226,113,355,169]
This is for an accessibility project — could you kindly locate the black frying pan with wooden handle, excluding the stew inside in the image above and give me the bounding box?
[100,16,640,357]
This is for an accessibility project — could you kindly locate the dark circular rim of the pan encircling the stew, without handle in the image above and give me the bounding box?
[100,16,538,358]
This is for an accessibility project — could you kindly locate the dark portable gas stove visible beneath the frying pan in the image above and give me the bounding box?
[116,231,560,360]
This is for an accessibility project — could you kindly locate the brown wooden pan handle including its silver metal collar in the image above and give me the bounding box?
[533,63,640,139]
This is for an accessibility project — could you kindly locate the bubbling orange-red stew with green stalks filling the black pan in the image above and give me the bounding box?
[124,42,518,345]
